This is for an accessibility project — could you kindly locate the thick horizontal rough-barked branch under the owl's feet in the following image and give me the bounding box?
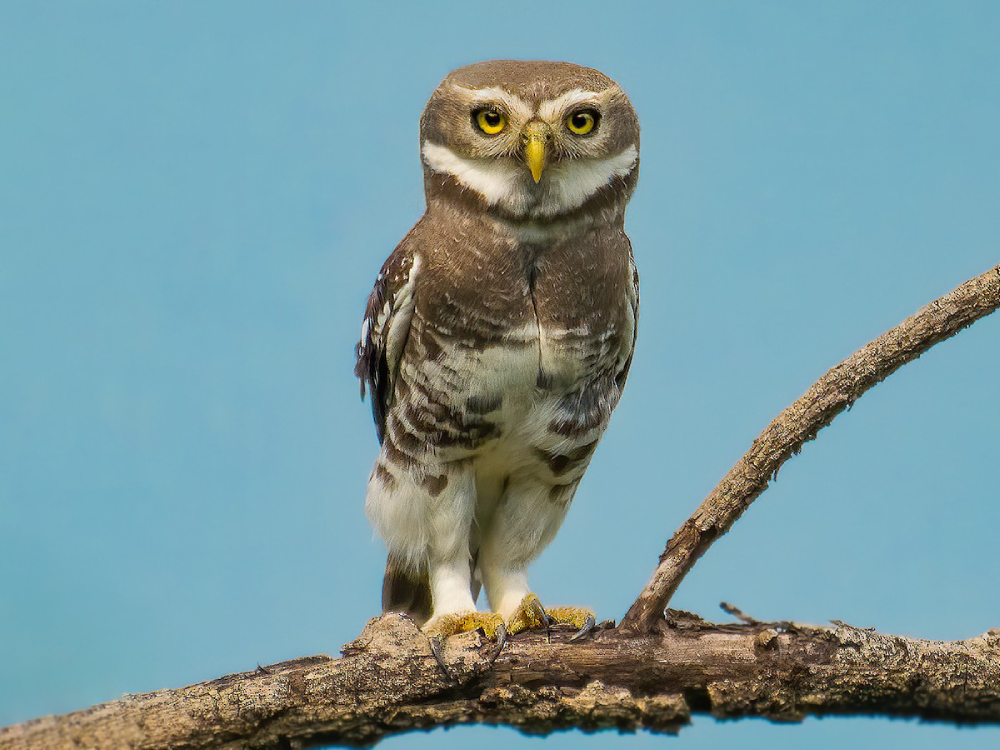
[0,612,1000,750]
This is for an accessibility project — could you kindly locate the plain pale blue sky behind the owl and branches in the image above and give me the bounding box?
[0,0,1000,749]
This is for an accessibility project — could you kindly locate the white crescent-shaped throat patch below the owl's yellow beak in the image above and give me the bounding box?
[423,141,639,217]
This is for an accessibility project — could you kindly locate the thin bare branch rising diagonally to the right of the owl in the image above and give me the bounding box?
[620,266,1000,631]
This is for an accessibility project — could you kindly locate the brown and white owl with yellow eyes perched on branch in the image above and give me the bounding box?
[356,60,639,636]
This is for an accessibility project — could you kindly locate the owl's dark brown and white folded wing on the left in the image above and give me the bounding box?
[354,245,419,443]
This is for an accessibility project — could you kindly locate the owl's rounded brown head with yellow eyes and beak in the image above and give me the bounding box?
[420,60,639,220]
